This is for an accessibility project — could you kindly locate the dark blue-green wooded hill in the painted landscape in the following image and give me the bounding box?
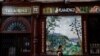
[47,33,69,49]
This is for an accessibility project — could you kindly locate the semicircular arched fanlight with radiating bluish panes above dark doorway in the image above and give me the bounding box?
[1,17,31,32]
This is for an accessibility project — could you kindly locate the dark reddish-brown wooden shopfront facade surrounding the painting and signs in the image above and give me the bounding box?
[0,0,100,56]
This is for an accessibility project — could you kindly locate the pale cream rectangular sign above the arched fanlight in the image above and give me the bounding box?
[2,6,32,15]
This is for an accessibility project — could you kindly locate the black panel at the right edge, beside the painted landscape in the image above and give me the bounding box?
[87,15,100,55]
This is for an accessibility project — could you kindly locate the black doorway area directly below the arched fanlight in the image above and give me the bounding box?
[0,34,31,56]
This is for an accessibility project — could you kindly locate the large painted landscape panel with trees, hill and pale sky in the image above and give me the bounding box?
[46,16,82,55]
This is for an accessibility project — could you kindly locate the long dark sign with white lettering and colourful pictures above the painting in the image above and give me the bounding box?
[43,6,100,14]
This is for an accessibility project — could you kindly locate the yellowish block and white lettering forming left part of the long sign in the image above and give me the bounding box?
[43,7,75,14]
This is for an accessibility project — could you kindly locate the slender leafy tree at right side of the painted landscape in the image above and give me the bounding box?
[69,18,82,46]
